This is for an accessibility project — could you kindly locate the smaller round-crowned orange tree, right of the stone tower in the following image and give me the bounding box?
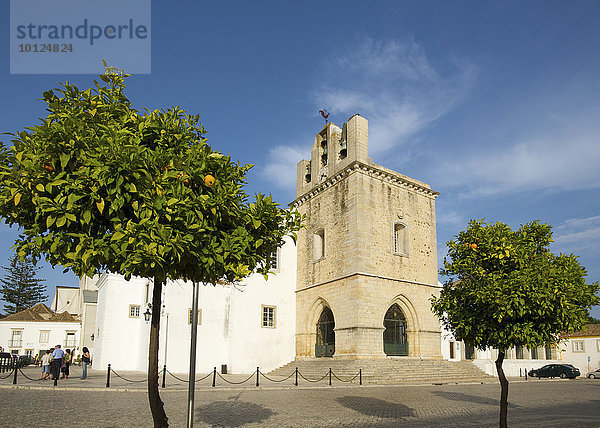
[432,220,599,427]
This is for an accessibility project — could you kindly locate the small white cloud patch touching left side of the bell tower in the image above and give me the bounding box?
[261,145,310,190]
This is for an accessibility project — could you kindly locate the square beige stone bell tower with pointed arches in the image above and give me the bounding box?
[290,114,441,358]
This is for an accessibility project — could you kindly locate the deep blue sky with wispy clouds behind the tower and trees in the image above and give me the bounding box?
[0,1,600,317]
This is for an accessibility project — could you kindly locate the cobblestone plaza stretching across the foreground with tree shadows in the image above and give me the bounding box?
[0,368,600,428]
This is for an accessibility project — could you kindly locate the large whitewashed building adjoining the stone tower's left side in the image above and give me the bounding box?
[93,239,296,373]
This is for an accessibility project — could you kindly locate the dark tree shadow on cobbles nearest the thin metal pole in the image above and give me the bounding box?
[195,401,275,427]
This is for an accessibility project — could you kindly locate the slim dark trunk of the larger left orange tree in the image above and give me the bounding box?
[148,277,169,428]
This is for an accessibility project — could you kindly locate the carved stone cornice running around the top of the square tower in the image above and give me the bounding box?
[289,161,439,208]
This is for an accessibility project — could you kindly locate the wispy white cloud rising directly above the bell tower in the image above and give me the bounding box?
[314,38,476,154]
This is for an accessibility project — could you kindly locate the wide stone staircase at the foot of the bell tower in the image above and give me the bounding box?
[268,357,497,385]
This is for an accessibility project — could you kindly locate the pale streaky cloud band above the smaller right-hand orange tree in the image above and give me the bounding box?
[432,128,600,196]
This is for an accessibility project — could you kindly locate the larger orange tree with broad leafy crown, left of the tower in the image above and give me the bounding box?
[0,64,301,427]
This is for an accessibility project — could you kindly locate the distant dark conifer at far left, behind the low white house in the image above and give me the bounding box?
[0,255,46,314]
